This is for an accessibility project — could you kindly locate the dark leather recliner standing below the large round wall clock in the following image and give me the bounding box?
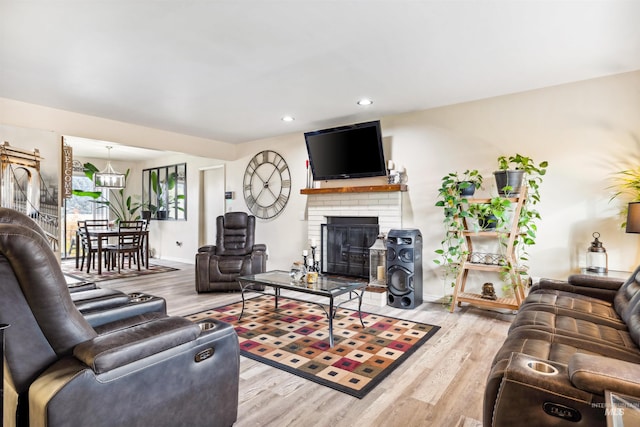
[196,212,267,293]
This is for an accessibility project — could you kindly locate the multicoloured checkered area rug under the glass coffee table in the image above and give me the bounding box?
[185,296,440,399]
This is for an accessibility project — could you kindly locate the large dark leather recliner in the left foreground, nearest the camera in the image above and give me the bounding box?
[0,208,239,426]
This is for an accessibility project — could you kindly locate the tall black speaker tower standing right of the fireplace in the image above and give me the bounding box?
[387,229,422,308]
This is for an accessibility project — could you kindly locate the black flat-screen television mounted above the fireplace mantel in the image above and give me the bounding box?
[304,120,387,181]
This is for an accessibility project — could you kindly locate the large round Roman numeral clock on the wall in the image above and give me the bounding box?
[242,150,291,219]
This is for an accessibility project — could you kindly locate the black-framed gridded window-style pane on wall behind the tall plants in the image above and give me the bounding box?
[142,163,187,221]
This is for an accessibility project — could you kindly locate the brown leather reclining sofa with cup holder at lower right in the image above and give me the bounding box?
[484,267,640,427]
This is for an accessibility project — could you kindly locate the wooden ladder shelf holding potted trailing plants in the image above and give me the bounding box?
[450,183,527,312]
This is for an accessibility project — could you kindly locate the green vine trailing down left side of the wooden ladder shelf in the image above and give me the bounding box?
[434,170,482,287]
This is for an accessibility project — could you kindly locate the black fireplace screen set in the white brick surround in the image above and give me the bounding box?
[321,222,380,278]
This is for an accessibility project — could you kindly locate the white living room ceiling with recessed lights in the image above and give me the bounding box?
[0,0,640,147]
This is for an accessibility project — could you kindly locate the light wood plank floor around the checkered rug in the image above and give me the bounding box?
[99,260,513,427]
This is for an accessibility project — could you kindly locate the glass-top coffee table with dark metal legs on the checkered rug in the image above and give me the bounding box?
[238,270,367,347]
